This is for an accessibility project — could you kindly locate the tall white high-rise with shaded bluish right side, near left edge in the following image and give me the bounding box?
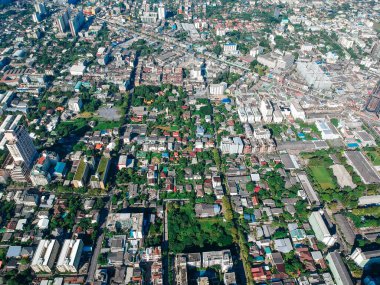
[4,126,37,168]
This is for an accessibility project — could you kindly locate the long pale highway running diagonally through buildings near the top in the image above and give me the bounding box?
[97,17,250,71]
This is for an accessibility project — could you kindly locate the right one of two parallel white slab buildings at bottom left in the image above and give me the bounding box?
[57,239,83,273]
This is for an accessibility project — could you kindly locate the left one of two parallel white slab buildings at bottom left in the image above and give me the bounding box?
[30,239,59,273]
